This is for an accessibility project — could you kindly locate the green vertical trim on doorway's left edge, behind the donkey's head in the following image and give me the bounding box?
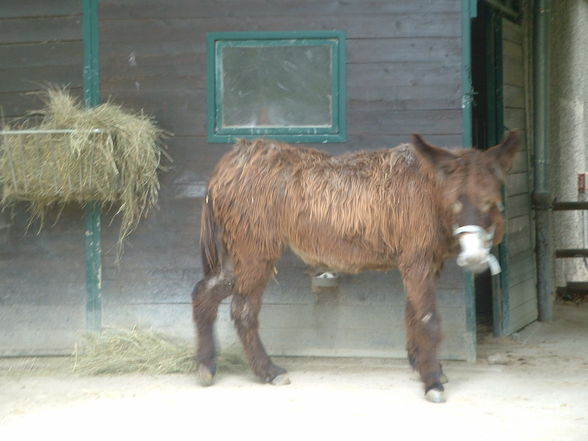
[461,0,477,362]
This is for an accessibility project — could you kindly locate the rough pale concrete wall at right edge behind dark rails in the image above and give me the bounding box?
[551,0,588,286]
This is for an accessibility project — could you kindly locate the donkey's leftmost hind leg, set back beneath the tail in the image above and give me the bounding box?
[192,273,233,386]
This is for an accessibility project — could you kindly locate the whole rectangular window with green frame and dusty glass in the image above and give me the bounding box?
[208,31,346,142]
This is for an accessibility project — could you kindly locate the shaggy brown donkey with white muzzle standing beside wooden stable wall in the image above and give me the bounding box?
[192,131,518,402]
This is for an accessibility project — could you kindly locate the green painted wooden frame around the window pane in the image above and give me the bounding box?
[207,31,347,143]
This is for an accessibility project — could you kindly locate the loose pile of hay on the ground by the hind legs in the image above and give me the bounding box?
[73,328,246,375]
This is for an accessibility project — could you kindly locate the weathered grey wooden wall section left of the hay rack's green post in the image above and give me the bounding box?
[0,0,85,355]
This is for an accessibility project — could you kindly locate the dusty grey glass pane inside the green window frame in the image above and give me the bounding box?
[220,45,332,127]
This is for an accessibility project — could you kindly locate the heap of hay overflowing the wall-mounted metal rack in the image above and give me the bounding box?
[0,88,165,257]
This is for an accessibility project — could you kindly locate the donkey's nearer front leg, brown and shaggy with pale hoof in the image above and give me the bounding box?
[402,265,445,403]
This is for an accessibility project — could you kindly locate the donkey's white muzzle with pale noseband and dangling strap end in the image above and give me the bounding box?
[453,225,500,276]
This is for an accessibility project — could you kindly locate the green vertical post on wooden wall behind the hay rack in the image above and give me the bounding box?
[83,0,102,332]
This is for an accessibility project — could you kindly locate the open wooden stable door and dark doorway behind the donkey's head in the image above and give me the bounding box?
[472,1,537,335]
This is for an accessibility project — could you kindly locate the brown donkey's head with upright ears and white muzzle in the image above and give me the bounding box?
[413,130,519,274]
